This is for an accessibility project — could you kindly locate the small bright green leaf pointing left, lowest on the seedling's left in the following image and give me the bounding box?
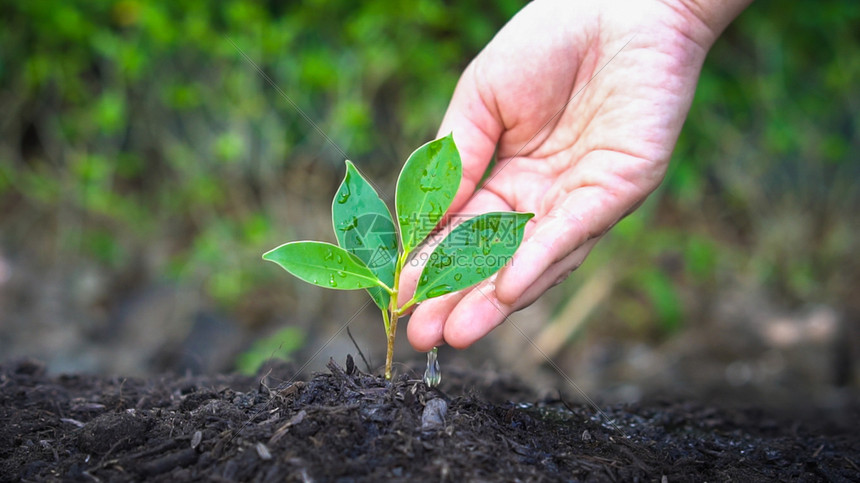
[263,241,379,290]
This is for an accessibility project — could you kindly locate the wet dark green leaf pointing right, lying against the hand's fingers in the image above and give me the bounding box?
[415,212,534,303]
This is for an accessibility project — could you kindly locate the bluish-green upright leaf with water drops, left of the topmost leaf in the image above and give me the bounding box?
[331,160,397,310]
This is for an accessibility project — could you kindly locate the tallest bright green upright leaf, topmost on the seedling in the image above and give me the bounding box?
[394,134,463,253]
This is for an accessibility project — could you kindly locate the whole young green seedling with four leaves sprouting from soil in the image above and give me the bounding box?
[263,135,534,379]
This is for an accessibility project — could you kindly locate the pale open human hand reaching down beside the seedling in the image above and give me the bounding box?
[398,0,750,351]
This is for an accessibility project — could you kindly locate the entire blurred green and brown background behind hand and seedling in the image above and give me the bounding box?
[0,0,860,399]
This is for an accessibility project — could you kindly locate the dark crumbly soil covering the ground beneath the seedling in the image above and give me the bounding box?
[0,358,860,482]
